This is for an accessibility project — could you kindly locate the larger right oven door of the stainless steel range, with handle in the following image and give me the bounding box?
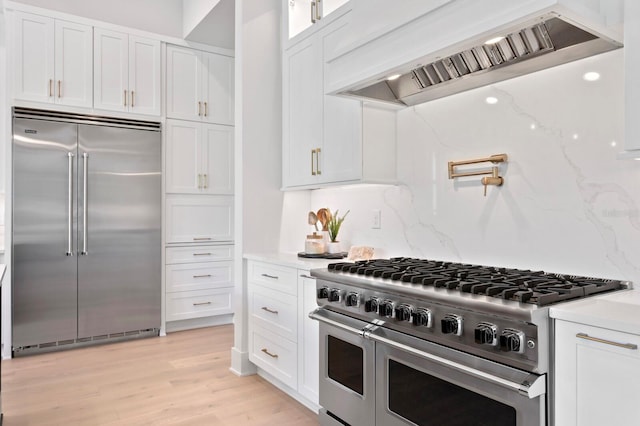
[368,327,546,426]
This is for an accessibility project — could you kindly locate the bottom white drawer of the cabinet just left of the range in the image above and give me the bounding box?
[249,327,298,389]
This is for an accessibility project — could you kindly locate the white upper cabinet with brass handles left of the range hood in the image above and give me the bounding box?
[282,9,395,189]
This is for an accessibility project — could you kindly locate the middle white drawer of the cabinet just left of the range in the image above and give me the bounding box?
[249,286,298,342]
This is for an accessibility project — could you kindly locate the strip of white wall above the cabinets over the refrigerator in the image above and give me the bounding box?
[8,0,182,38]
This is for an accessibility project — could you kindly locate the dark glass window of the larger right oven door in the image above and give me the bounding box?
[388,359,516,426]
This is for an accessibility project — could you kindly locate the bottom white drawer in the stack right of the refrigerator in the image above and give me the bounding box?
[167,287,233,321]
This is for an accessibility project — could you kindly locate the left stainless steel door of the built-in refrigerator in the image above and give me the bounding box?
[12,118,77,347]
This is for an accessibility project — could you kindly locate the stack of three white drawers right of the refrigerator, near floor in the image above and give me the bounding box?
[165,245,233,322]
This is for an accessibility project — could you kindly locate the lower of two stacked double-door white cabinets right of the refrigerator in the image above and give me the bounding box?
[166,120,233,194]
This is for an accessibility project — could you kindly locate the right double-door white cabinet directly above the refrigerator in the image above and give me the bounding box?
[94,28,161,116]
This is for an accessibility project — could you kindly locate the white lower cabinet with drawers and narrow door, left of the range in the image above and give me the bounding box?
[247,260,319,409]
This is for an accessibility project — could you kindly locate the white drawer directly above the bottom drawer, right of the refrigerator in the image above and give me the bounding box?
[166,261,233,293]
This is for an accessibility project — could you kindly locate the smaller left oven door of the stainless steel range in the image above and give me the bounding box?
[311,309,376,426]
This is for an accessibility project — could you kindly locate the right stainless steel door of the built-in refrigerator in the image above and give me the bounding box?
[78,125,161,338]
